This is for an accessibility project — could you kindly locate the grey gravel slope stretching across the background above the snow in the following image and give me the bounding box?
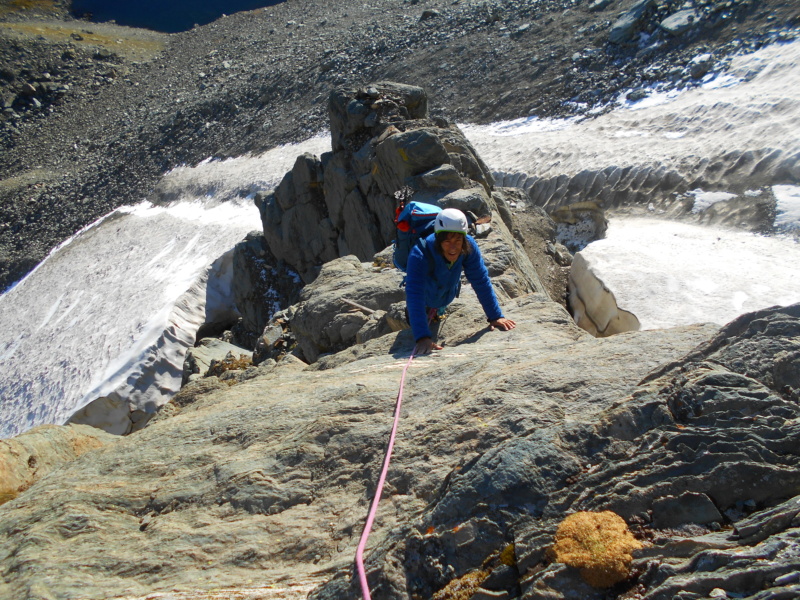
[0,0,800,290]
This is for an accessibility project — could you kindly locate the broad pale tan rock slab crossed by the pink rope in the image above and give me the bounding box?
[0,286,714,599]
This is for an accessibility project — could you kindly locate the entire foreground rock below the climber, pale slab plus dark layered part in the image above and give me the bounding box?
[0,236,800,600]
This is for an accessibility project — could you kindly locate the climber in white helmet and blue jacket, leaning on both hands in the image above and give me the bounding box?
[406,208,516,354]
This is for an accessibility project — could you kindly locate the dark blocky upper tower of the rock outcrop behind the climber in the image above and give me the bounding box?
[255,83,493,283]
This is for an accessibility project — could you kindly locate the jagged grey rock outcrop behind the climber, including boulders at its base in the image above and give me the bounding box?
[250,83,547,362]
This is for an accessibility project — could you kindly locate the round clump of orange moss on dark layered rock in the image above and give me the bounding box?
[550,511,642,588]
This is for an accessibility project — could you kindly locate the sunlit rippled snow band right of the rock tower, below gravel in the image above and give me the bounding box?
[464,41,800,209]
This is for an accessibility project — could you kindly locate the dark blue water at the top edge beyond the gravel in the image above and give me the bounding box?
[72,0,283,33]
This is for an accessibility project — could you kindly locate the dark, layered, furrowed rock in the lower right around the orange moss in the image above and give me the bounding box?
[312,305,800,600]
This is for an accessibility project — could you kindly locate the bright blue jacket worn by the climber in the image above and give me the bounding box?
[406,233,503,340]
